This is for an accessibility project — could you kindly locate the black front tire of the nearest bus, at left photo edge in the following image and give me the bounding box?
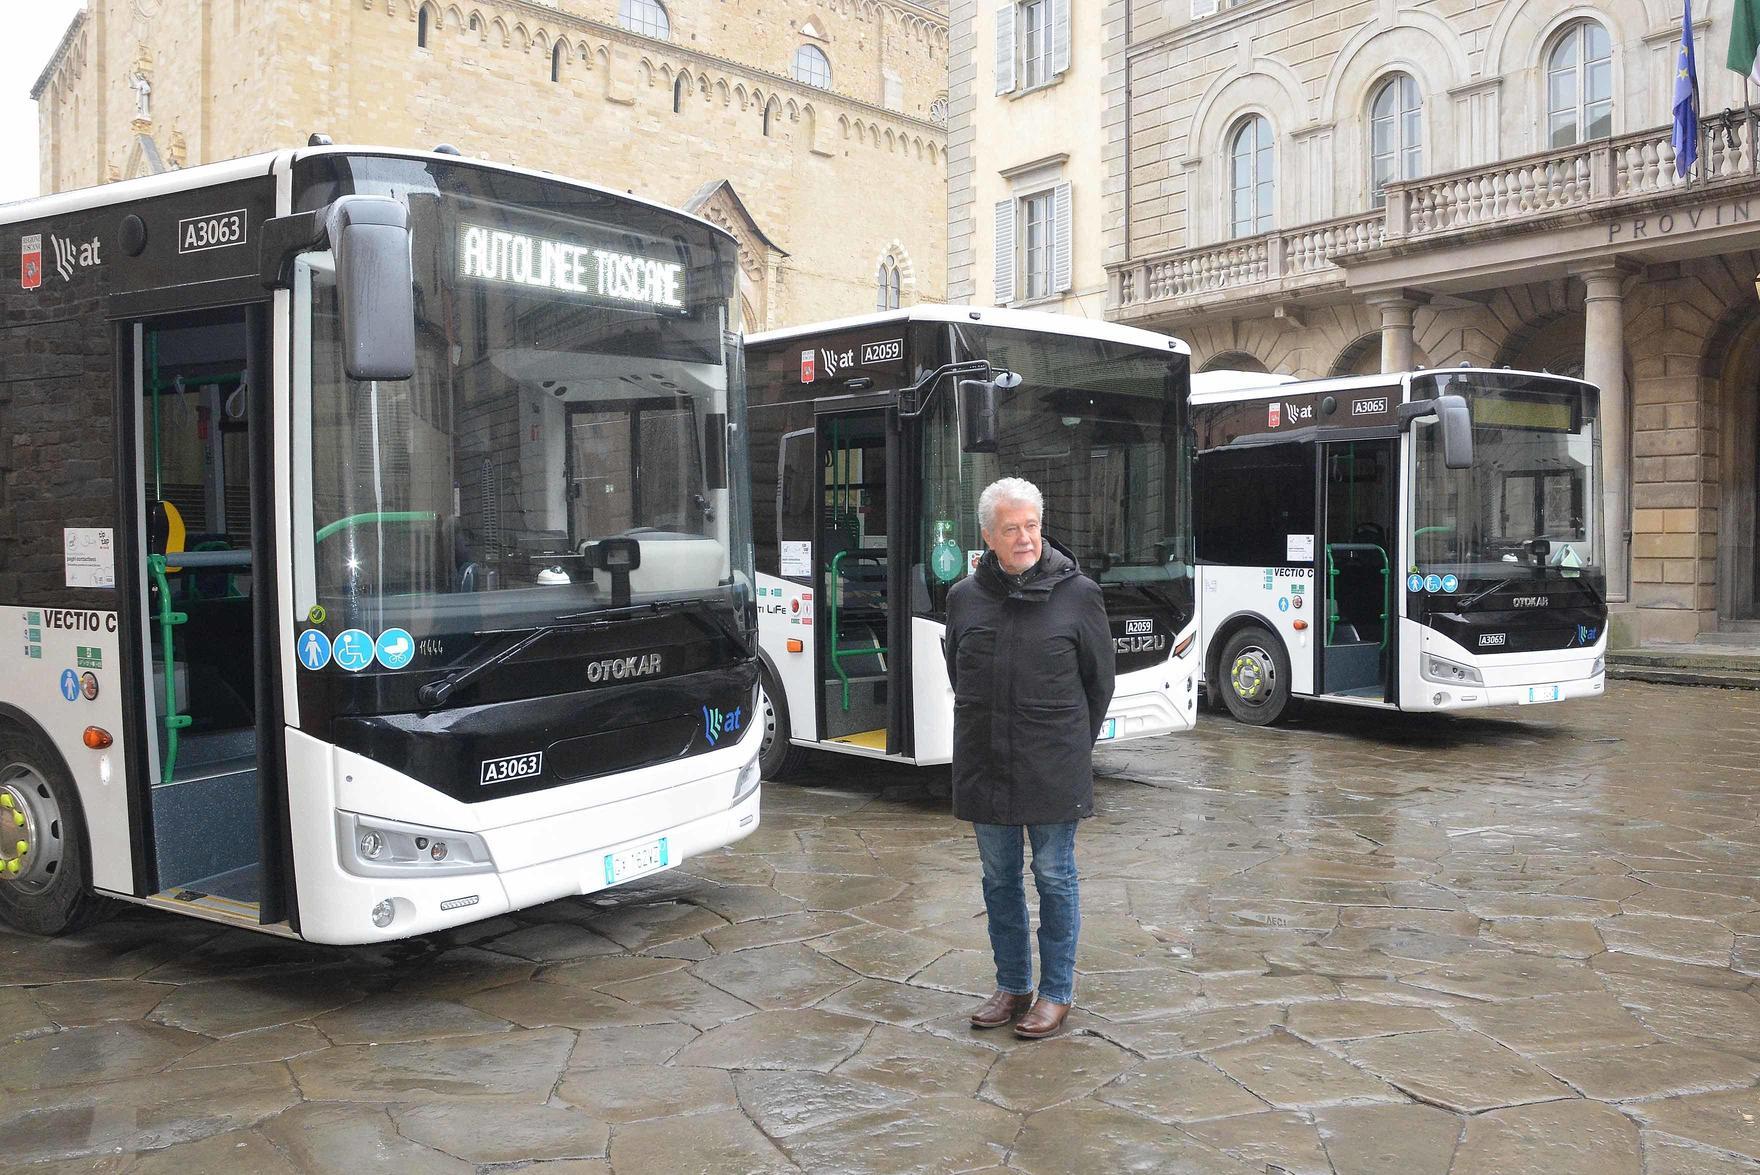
[0,726,114,934]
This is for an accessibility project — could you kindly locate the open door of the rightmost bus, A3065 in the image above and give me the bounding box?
[1315,440,1401,702]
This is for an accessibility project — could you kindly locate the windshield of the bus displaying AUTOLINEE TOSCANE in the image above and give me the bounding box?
[296,160,752,633]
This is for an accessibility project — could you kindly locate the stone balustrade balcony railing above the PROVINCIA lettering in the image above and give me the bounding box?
[1111,111,1760,317]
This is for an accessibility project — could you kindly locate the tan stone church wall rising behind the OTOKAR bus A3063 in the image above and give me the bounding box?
[32,0,947,331]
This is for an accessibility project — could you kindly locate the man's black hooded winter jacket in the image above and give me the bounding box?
[947,542,1112,825]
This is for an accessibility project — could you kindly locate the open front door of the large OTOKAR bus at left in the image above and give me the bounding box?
[124,306,285,925]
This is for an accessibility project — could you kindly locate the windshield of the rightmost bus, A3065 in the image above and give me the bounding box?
[1410,371,1605,591]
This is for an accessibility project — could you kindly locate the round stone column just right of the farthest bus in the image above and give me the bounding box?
[1579,264,1633,603]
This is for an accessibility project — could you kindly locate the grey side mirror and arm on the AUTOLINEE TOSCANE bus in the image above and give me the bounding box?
[259,195,415,380]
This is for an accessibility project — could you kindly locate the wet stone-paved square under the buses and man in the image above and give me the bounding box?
[0,682,1760,1175]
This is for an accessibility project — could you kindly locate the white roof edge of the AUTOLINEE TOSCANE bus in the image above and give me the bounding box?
[0,146,732,239]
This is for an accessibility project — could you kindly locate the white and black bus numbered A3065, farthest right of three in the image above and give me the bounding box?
[1192,368,1607,725]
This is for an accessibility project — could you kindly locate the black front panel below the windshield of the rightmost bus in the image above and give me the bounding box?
[1406,575,1607,654]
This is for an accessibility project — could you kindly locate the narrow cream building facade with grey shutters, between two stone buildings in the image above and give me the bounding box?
[947,0,1107,318]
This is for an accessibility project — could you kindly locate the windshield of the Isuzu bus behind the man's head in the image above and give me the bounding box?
[922,325,1192,624]
